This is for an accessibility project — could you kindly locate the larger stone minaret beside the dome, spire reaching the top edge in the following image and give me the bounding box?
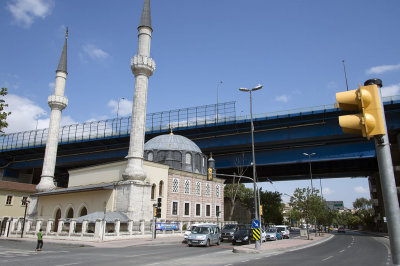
[122,0,156,181]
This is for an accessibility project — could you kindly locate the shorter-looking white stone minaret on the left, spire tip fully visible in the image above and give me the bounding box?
[36,28,68,192]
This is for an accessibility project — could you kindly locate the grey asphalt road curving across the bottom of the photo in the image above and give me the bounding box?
[0,233,391,266]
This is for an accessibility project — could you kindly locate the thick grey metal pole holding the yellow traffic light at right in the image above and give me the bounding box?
[364,80,400,265]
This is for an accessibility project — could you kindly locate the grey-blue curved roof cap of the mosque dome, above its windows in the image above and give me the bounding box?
[144,134,201,153]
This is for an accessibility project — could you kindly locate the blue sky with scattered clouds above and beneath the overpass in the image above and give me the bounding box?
[0,0,400,208]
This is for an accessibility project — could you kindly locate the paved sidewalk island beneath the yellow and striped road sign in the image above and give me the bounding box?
[233,234,334,253]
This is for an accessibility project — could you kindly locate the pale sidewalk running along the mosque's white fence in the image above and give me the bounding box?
[1,235,183,248]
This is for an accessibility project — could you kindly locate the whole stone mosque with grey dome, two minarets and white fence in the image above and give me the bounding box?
[0,0,228,240]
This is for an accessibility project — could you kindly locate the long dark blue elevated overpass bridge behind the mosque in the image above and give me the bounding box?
[0,96,400,185]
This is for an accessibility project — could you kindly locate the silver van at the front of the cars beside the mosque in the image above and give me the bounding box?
[187,225,221,247]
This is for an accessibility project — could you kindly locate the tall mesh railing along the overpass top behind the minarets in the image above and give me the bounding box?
[0,102,236,151]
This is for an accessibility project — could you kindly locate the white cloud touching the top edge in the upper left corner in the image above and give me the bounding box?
[7,0,55,28]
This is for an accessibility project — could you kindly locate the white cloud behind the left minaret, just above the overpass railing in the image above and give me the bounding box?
[4,94,76,133]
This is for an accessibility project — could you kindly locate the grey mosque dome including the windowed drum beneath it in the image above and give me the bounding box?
[144,133,207,174]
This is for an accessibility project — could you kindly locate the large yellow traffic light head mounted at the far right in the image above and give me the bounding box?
[336,84,386,139]
